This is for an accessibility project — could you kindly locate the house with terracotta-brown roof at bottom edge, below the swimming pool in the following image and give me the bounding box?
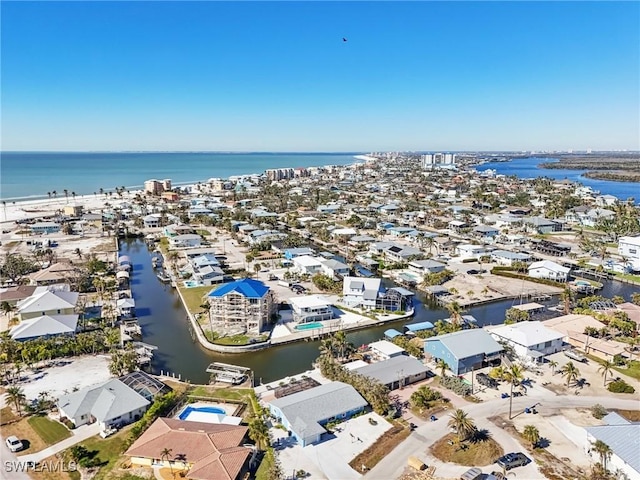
[125,417,252,480]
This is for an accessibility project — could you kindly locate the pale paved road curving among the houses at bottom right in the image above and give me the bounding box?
[363,389,640,480]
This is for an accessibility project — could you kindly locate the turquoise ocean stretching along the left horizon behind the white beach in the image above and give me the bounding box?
[0,152,359,201]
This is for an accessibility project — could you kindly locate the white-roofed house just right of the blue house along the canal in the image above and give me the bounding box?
[487,321,564,361]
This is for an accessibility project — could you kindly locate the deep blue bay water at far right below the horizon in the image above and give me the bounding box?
[477,157,640,203]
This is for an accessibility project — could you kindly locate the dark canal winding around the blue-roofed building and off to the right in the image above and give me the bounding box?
[120,239,638,383]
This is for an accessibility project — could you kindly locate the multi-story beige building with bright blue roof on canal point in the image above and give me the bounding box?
[207,278,275,334]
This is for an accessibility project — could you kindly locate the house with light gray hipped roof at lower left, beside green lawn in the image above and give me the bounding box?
[56,378,150,430]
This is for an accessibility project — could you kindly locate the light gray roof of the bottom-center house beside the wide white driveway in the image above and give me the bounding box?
[271,382,367,437]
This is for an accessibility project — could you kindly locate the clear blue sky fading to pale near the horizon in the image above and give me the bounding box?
[1,1,640,151]
